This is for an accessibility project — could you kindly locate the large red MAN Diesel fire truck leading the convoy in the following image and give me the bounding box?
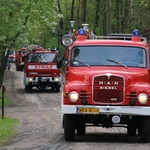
[57,24,150,142]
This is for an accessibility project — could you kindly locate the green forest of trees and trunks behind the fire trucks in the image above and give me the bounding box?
[0,0,150,52]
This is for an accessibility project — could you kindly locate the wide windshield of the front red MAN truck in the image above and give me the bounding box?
[71,46,146,68]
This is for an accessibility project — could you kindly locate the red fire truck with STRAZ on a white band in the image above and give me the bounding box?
[24,47,62,92]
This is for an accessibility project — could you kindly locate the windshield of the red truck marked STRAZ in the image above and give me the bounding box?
[28,53,57,63]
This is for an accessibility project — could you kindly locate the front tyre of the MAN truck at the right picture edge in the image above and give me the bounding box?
[141,117,150,143]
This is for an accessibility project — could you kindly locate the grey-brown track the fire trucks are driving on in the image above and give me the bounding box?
[0,64,150,150]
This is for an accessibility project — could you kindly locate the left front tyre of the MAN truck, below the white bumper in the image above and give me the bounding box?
[64,114,75,141]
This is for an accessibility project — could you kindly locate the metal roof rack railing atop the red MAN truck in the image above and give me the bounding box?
[95,33,147,44]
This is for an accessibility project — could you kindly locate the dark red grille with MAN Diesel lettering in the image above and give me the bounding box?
[93,75,124,104]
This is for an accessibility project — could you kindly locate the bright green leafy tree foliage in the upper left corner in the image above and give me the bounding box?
[0,0,60,48]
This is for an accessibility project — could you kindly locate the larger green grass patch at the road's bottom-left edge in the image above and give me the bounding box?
[0,117,19,147]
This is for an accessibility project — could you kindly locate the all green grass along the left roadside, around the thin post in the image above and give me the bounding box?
[0,93,19,147]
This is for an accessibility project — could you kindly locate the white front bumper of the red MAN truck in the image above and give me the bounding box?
[61,105,150,116]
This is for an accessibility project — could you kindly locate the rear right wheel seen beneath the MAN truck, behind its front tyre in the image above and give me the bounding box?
[127,120,136,136]
